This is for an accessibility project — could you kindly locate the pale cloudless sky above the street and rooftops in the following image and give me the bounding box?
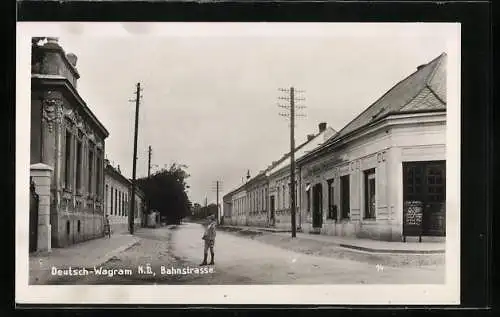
[38,23,454,203]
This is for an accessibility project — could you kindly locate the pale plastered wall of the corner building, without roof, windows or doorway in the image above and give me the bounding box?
[300,115,446,240]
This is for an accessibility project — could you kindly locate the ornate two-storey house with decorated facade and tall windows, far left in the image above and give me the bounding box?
[29,38,109,251]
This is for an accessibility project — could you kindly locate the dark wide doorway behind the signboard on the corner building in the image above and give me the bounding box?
[403,161,446,236]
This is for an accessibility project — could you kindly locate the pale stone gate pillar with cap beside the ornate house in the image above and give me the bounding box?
[30,163,53,251]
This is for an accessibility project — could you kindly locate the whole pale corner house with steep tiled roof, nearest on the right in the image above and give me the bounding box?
[297,53,447,241]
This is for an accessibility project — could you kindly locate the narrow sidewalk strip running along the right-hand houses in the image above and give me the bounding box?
[219,226,445,254]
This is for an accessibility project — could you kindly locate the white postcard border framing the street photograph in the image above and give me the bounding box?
[15,22,460,305]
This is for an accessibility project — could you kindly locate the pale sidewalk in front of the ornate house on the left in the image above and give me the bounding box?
[29,234,139,284]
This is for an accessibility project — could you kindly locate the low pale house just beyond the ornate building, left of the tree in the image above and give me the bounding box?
[104,160,146,233]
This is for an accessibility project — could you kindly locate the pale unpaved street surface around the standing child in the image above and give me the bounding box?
[41,223,445,285]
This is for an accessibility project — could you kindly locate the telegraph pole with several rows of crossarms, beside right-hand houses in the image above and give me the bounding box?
[279,87,305,238]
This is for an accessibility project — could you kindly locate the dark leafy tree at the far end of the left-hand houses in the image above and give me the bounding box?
[137,163,191,224]
